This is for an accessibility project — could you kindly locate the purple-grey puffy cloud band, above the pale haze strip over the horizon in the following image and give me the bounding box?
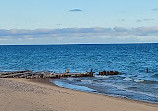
[0,27,158,38]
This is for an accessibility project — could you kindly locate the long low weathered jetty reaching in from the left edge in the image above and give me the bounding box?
[0,69,94,79]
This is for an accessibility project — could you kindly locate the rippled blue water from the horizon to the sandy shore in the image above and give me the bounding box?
[0,44,158,102]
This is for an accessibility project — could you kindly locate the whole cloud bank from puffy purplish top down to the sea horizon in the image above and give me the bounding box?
[0,27,158,44]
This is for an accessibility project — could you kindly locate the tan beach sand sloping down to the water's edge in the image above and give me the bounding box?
[0,78,158,111]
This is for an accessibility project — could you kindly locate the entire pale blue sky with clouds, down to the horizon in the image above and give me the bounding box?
[0,0,158,45]
